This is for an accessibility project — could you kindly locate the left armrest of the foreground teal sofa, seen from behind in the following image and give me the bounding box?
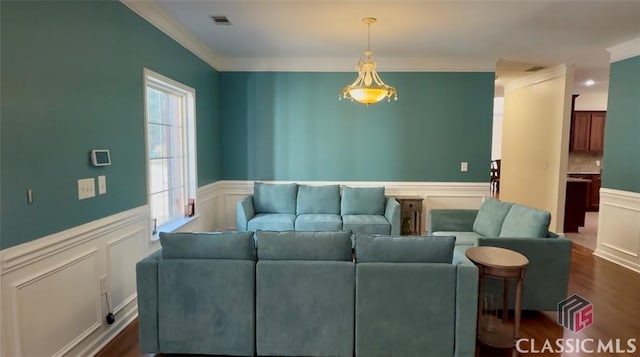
[136,249,162,353]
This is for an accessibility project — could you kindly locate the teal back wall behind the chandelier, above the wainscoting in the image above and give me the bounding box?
[220,72,494,182]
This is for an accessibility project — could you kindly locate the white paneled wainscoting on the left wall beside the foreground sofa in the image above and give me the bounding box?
[0,206,158,356]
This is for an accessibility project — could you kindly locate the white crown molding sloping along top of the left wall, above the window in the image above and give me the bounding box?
[120,0,224,70]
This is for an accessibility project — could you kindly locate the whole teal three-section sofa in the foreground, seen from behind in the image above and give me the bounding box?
[136,231,478,357]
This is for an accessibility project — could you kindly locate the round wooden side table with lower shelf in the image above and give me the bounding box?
[465,246,529,348]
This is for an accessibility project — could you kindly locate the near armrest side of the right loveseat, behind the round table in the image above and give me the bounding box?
[478,237,571,311]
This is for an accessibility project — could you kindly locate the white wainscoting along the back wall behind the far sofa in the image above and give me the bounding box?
[212,181,490,230]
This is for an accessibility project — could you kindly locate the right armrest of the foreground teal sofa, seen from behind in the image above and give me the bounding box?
[453,251,478,357]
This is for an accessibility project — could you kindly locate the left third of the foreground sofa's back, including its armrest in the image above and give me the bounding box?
[136,232,257,356]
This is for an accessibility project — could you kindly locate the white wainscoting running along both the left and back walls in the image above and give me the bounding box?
[0,181,489,356]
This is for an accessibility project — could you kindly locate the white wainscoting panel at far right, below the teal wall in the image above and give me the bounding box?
[594,188,640,272]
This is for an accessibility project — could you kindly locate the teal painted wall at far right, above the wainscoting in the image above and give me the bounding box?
[602,56,640,193]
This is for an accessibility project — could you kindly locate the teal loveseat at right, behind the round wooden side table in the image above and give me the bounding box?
[429,198,571,311]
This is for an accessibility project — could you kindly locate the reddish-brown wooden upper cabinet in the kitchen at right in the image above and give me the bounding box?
[569,111,607,152]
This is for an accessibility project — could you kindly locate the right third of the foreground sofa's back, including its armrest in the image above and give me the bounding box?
[355,235,478,357]
